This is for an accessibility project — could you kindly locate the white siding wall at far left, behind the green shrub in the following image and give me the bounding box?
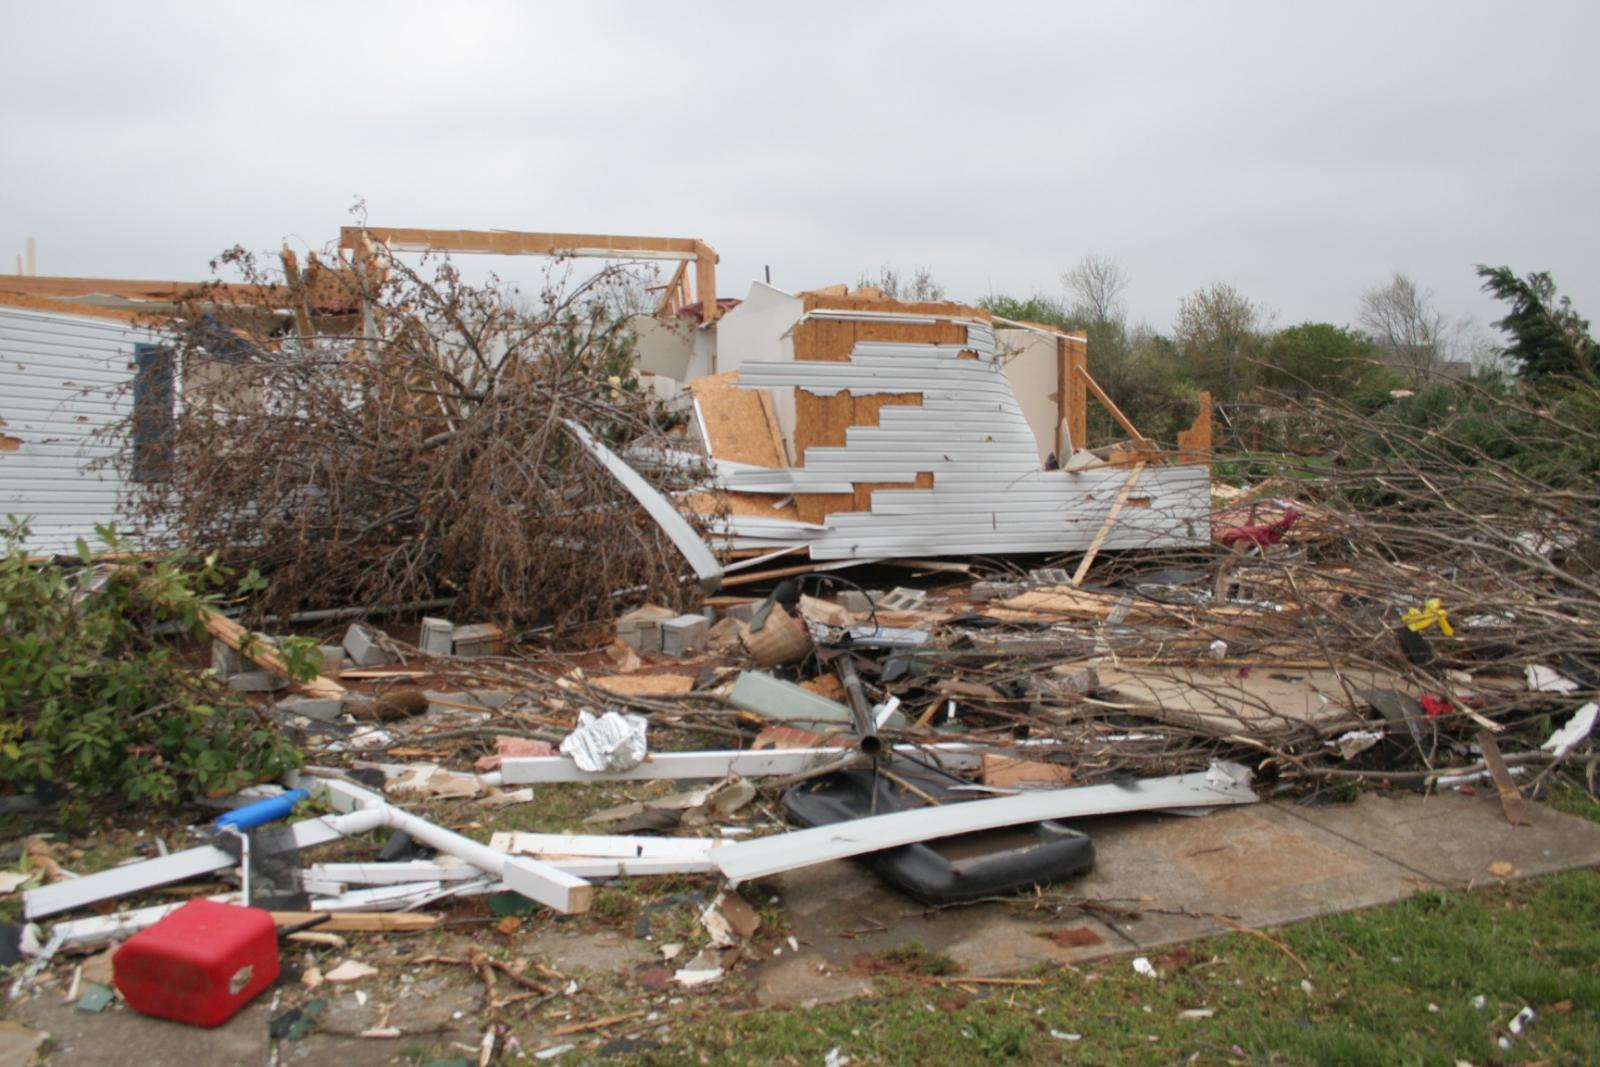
[0,307,163,555]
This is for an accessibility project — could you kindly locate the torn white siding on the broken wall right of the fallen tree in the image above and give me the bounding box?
[718,326,1211,560]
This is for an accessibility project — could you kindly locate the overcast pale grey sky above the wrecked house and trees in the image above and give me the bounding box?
[0,0,1600,337]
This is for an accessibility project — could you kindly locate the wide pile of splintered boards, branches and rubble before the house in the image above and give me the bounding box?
[9,508,1597,1017]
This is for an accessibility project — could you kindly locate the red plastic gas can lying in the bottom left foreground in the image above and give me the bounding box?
[110,901,278,1027]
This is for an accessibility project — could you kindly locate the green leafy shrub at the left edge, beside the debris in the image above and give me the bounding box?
[0,518,302,816]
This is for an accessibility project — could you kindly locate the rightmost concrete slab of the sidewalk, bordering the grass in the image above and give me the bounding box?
[1280,789,1600,888]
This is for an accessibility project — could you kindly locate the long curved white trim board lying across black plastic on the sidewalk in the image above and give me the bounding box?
[710,763,1258,885]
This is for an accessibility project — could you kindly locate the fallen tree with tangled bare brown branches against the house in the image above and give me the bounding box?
[122,250,707,625]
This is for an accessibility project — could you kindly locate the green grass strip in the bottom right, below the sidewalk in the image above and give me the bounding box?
[643,870,1600,1067]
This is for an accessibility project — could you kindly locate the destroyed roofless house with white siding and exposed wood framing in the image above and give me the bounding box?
[0,227,1210,577]
